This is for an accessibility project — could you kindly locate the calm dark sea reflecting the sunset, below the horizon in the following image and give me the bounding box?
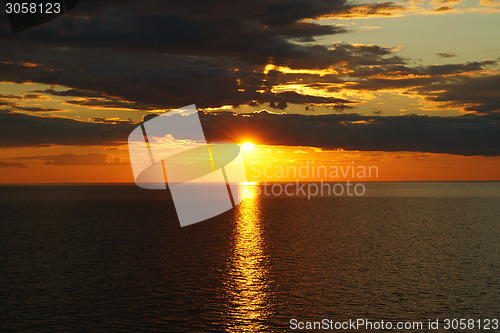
[0,182,500,332]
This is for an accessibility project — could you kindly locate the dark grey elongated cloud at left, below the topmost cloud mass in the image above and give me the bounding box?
[0,49,250,108]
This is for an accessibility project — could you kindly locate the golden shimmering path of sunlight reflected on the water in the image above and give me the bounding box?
[226,185,269,332]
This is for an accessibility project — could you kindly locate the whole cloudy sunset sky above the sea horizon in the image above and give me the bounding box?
[0,0,500,183]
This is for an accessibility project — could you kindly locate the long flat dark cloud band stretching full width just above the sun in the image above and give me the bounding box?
[0,112,500,156]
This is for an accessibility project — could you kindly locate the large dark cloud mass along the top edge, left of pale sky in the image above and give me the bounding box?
[0,0,352,64]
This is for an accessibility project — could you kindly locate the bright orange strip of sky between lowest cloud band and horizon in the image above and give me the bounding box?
[0,141,500,184]
